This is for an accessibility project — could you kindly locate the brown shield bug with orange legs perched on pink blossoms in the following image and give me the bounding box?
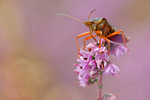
[57,9,129,55]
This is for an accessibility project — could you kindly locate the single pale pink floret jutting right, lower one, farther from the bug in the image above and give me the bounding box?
[103,63,120,77]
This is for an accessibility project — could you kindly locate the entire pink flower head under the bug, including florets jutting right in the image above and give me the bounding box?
[75,40,128,87]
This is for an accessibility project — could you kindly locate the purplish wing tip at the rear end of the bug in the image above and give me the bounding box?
[108,34,130,43]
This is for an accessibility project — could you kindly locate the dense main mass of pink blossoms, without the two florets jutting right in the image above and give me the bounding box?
[75,43,109,87]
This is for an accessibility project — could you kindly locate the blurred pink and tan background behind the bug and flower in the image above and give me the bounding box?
[0,0,150,100]
